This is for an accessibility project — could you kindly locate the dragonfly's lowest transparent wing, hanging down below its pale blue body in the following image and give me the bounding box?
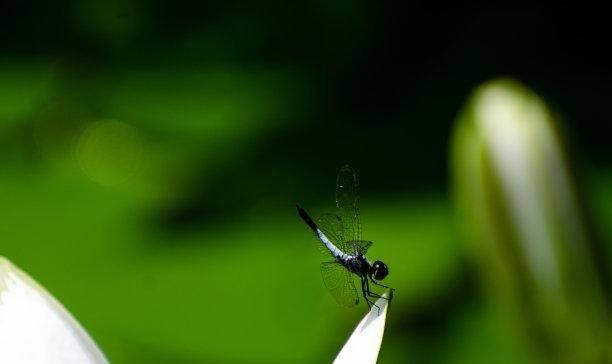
[321,262,359,307]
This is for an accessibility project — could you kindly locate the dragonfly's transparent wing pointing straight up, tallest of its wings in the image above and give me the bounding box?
[336,166,361,241]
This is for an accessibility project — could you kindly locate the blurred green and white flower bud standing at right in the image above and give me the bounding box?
[451,79,608,363]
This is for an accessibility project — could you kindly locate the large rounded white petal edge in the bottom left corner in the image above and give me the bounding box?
[0,256,108,364]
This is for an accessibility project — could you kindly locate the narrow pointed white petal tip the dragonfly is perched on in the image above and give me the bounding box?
[334,292,393,364]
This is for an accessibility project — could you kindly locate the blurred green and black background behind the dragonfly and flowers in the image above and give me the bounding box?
[0,0,612,364]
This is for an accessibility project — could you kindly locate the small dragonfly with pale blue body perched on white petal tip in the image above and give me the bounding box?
[296,165,393,310]
